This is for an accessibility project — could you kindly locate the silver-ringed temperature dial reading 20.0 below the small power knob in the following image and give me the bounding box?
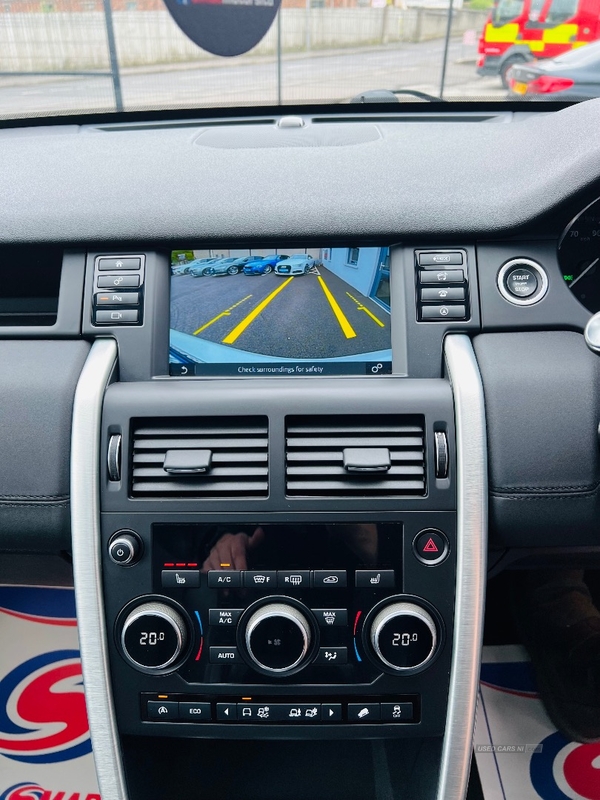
[121,602,188,672]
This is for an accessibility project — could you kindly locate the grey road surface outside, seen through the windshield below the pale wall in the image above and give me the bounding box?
[0,39,506,118]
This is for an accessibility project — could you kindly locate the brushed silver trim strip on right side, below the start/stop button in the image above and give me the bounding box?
[437,334,487,800]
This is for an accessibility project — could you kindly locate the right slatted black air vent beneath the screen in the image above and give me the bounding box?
[286,415,426,497]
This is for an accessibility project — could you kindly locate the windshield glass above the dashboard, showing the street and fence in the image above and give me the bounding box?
[0,0,600,119]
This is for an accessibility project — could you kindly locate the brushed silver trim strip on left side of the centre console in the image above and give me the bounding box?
[71,339,127,800]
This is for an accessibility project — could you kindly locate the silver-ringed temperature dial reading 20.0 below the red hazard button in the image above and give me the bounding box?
[370,602,438,672]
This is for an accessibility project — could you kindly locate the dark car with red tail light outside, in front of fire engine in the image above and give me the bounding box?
[507,42,600,100]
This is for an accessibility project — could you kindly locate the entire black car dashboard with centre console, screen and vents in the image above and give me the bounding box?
[0,101,600,800]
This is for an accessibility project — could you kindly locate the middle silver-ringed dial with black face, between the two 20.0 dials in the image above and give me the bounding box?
[243,602,314,675]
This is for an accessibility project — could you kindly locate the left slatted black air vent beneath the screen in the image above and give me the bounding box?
[131,417,268,499]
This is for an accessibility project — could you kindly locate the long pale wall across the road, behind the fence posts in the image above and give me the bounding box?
[0,6,487,73]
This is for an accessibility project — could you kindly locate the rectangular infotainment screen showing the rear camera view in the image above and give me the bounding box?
[169,247,392,377]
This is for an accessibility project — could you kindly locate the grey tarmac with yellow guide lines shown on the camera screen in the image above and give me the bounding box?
[171,266,390,361]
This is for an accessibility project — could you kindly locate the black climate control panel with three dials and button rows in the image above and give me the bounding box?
[105,514,455,737]
